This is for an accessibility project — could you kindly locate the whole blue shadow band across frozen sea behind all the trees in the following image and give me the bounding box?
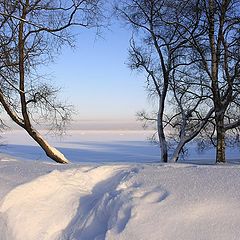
[0,141,240,164]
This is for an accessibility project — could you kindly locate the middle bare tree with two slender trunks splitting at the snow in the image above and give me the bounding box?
[117,0,213,162]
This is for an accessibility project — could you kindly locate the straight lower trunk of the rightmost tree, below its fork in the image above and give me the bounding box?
[216,114,226,163]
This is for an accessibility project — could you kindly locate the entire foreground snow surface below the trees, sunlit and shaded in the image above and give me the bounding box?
[0,156,240,240]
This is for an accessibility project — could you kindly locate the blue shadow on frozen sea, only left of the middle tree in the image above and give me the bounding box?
[0,141,159,163]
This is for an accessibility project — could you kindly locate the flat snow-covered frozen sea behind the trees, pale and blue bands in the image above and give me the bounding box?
[0,130,240,164]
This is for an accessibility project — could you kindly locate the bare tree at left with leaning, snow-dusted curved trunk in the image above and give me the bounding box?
[0,0,100,163]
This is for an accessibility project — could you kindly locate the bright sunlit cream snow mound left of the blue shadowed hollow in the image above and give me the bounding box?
[0,166,129,240]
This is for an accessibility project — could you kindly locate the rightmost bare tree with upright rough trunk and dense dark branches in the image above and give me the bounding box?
[176,0,240,163]
